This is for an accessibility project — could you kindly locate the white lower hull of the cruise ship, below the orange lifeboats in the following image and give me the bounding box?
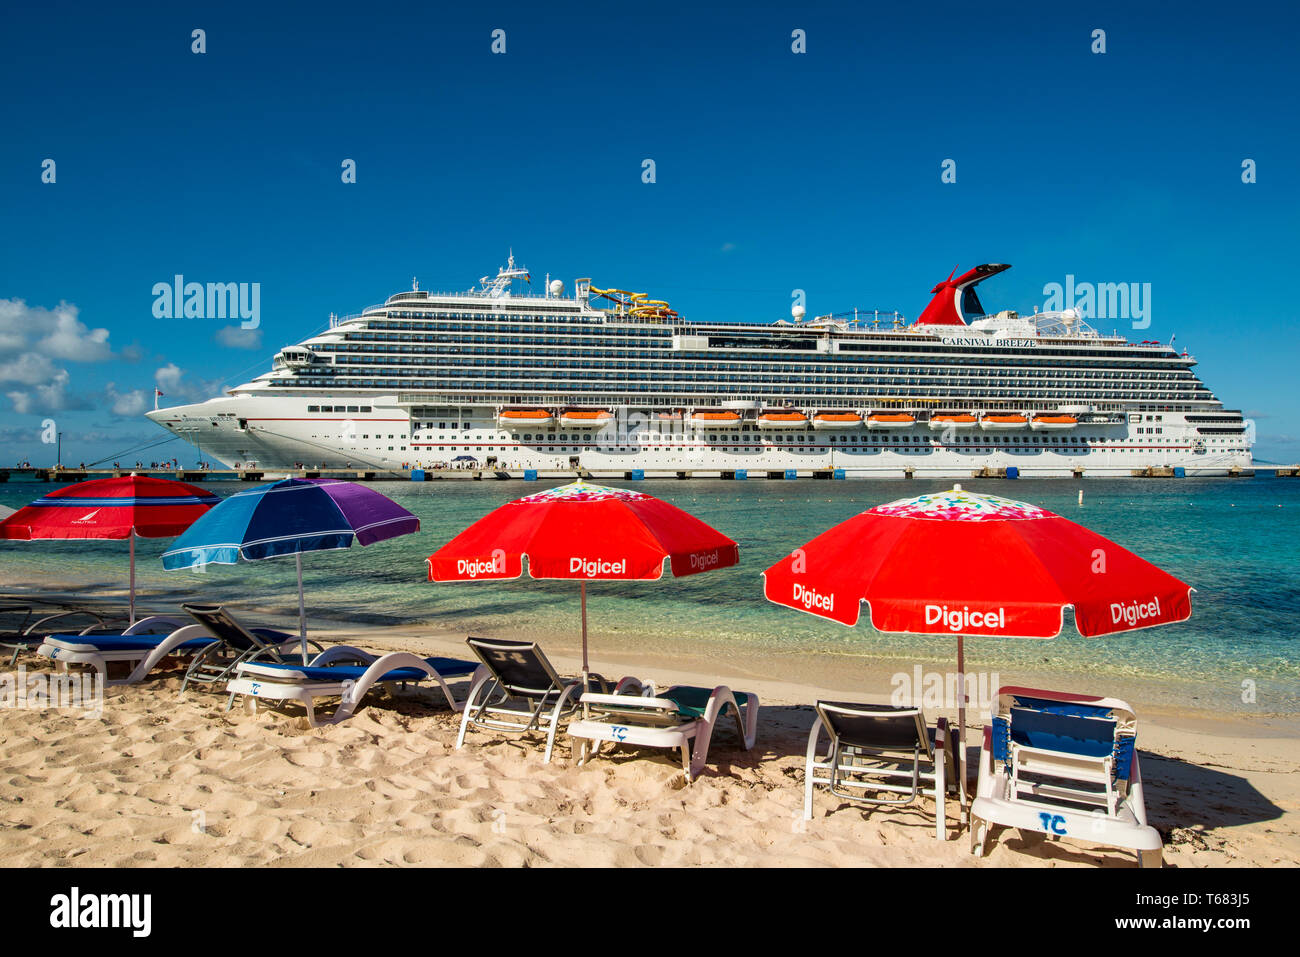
[148,394,1253,479]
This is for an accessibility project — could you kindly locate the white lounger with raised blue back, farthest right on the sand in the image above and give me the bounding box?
[971,687,1162,867]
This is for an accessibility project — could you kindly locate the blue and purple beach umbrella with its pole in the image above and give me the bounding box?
[163,479,420,661]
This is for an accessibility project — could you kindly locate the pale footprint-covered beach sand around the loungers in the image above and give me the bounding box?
[0,598,1300,867]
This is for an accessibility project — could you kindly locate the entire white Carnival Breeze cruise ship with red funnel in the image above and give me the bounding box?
[148,255,1253,479]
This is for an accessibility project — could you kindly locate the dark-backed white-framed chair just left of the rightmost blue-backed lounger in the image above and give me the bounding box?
[803,701,966,840]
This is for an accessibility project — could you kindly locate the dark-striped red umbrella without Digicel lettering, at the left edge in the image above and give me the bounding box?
[0,475,221,624]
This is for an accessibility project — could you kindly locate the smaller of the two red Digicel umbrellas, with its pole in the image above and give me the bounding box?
[428,481,740,672]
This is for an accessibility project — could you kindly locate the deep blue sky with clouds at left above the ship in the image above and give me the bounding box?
[0,3,1300,463]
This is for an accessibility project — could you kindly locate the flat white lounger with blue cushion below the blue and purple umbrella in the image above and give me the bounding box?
[226,645,482,728]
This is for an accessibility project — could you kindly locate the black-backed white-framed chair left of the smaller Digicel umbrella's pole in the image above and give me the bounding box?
[456,637,605,762]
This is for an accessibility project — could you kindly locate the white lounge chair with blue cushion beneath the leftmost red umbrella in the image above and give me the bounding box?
[36,615,220,685]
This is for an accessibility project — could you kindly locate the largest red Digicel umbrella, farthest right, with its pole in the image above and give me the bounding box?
[763,485,1192,748]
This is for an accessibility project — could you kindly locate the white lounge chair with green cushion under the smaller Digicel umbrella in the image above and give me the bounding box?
[568,679,758,783]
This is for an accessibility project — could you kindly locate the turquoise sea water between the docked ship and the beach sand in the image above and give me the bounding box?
[0,477,1300,714]
